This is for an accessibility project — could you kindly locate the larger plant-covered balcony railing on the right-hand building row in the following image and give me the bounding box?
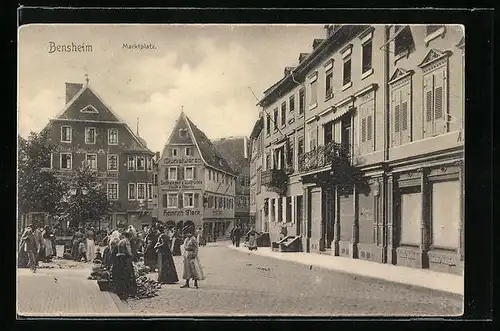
[299,141,350,171]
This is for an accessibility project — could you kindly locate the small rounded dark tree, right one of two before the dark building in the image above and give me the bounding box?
[62,165,111,229]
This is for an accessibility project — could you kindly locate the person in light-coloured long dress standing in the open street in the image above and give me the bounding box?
[181,226,204,288]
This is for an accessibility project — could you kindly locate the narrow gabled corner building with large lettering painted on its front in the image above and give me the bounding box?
[155,112,237,239]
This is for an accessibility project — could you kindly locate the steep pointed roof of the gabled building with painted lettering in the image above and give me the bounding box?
[166,112,236,176]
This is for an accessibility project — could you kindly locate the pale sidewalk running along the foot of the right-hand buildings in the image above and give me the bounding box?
[227,245,464,295]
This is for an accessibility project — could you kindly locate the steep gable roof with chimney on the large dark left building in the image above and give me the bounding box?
[48,83,153,154]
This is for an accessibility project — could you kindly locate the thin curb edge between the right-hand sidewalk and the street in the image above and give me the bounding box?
[227,245,464,297]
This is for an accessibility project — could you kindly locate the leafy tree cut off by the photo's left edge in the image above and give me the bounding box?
[18,132,65,220]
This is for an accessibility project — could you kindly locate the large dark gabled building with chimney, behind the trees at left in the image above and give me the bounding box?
[40,82,153,229]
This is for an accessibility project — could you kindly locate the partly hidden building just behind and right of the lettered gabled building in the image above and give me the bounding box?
[213,137,250,228]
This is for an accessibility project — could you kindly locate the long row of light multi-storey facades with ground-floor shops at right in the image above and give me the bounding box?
[252,25,464,273]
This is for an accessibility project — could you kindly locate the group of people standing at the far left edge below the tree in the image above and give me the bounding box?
[18,224,56,272]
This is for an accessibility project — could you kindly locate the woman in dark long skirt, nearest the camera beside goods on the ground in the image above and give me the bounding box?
[111,232,137,300]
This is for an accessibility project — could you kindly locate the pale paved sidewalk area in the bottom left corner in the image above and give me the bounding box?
[17,268,132,317]
